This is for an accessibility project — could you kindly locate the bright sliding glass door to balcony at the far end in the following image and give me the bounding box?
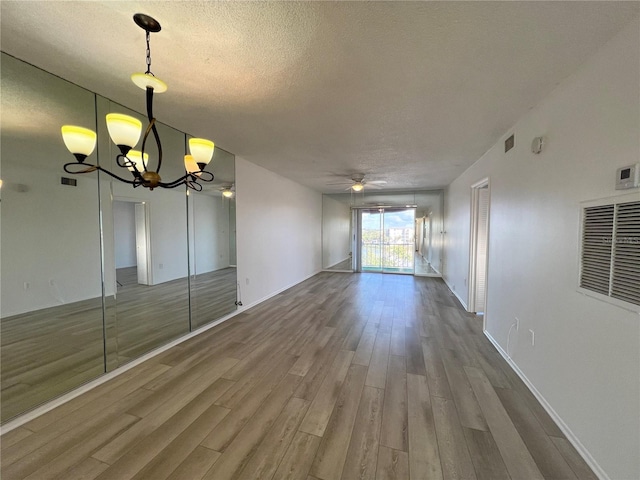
[357,207,415,275]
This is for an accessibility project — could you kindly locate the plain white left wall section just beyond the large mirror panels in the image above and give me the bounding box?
[236,157,322,308]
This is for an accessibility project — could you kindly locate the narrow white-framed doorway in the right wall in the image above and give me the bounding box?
[469,178,490,314]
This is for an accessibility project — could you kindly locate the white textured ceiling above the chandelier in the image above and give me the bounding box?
[0,0,640,193]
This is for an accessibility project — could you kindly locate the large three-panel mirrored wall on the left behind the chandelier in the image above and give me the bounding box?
[0,53,237,422]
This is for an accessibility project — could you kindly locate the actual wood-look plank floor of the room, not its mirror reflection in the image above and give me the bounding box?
[1,272,595,480]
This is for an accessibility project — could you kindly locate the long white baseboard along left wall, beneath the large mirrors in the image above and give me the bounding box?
[0,270,320,435]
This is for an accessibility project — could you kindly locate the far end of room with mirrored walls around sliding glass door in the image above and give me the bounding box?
[322,190,444,276]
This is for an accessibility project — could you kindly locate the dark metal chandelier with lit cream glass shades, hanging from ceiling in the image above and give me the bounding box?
[62,13,215,191]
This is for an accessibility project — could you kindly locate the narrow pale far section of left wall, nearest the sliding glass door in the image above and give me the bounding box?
[322,195,351,268]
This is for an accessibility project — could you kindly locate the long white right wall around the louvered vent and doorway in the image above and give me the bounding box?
[444,19,640,480]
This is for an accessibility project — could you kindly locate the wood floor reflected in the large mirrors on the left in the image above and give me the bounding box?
[0,267,236,422]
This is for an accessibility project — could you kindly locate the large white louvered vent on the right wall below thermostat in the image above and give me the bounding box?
[580,201,640,305]
